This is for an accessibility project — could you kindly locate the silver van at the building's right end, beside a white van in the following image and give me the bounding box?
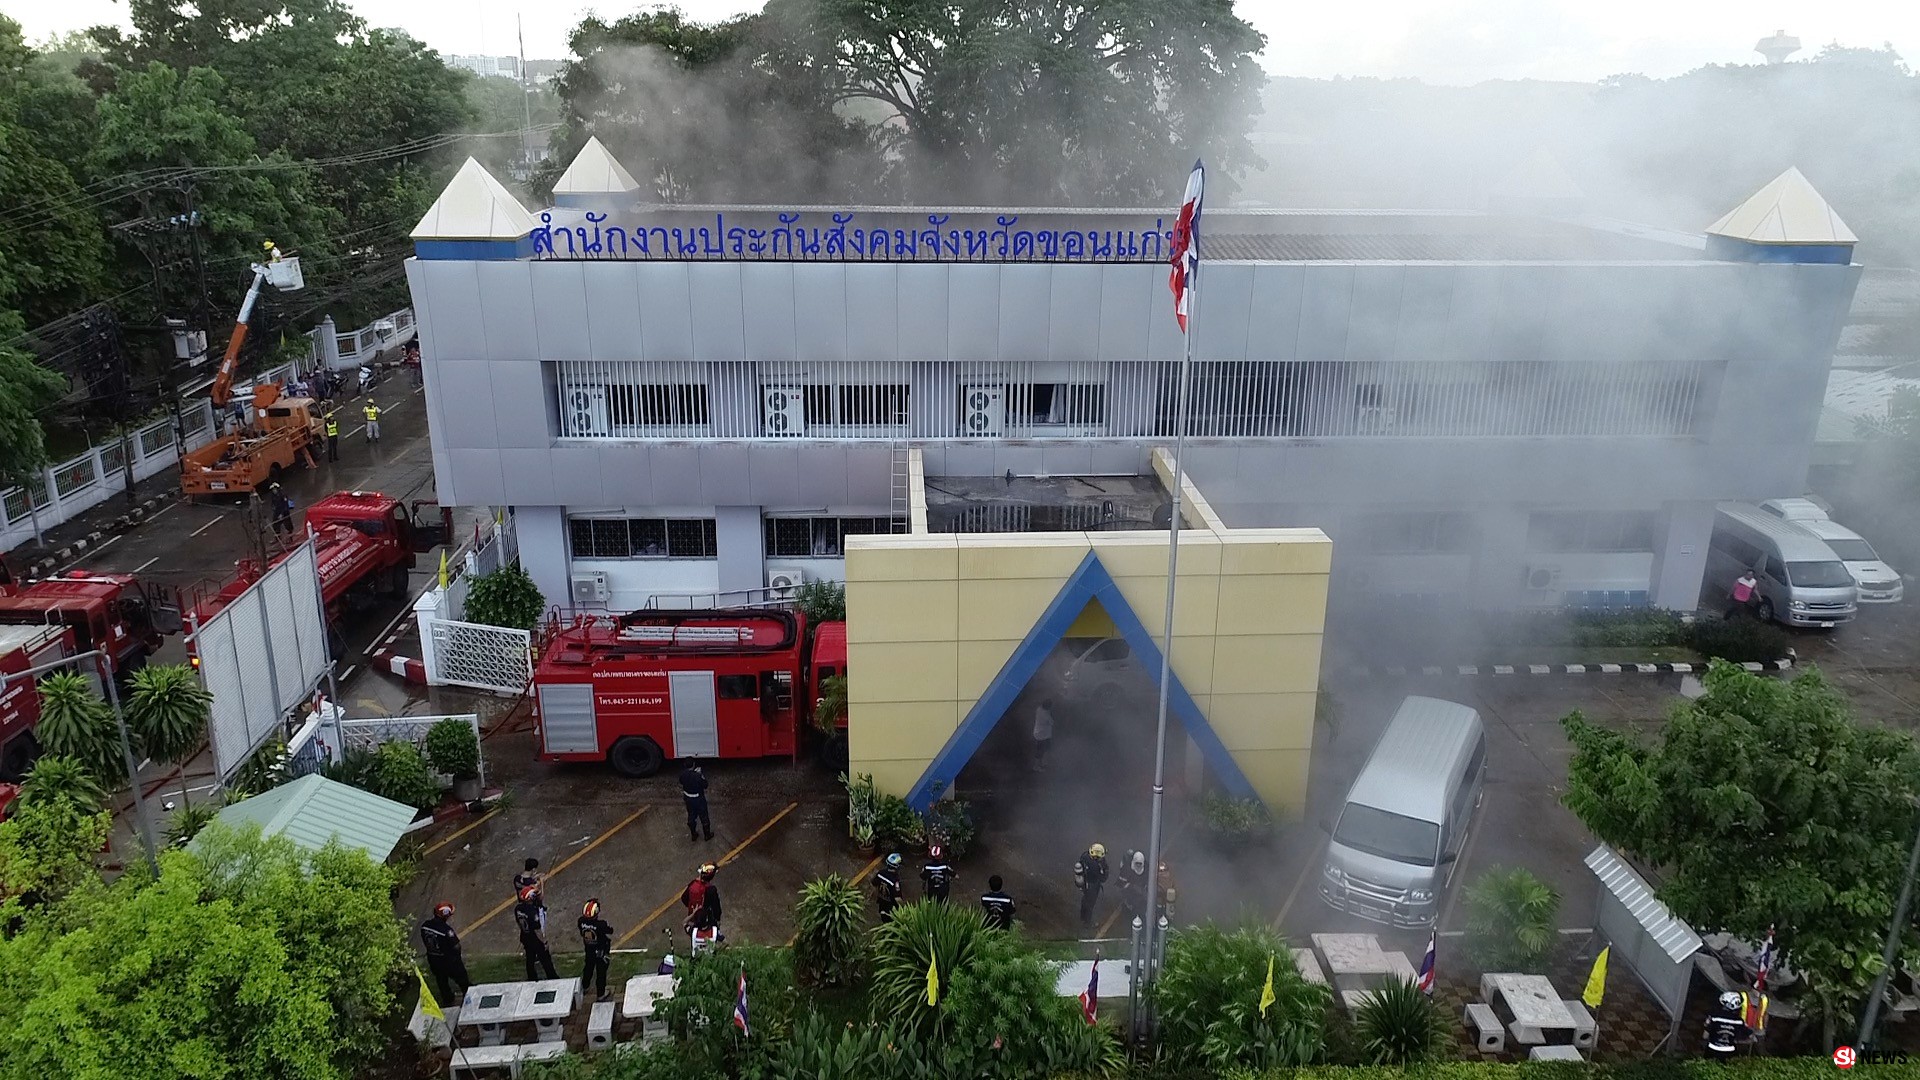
[1701,502,1860,626]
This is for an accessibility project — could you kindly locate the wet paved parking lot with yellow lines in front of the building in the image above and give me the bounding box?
[401,605,1920,967]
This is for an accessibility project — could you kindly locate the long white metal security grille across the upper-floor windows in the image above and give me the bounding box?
[553,359,1720,442]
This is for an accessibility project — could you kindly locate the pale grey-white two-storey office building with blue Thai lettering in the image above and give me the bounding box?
[407,140,1859,609]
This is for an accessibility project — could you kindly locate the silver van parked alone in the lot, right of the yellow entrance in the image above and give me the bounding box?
[1321,698,1486,928]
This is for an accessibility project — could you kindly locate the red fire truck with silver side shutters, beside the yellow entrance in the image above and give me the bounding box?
[534,607,847,776]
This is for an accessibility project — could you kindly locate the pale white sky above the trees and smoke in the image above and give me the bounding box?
[15,0,1920,85]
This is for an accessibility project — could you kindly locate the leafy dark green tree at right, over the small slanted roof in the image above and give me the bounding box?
[1563,661,1920,1042]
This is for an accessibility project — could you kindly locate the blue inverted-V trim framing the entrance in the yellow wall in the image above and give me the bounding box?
[906,552,1260,813]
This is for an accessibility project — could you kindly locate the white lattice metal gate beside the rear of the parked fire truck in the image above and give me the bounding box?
[413,513,534,694]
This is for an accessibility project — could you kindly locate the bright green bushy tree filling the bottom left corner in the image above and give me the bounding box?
[0,826,405,1080]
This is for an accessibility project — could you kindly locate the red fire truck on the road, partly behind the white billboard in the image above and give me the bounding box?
[186,492,451,651]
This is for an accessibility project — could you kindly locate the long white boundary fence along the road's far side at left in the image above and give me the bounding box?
[0,307,413,550]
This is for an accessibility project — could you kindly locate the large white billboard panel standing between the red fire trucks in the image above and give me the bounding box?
[192,538,330,780]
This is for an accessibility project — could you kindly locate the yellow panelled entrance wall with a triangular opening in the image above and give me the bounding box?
[847,511,1332,813]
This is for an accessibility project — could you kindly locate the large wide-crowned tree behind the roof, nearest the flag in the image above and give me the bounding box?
[764,0,1265,206]
